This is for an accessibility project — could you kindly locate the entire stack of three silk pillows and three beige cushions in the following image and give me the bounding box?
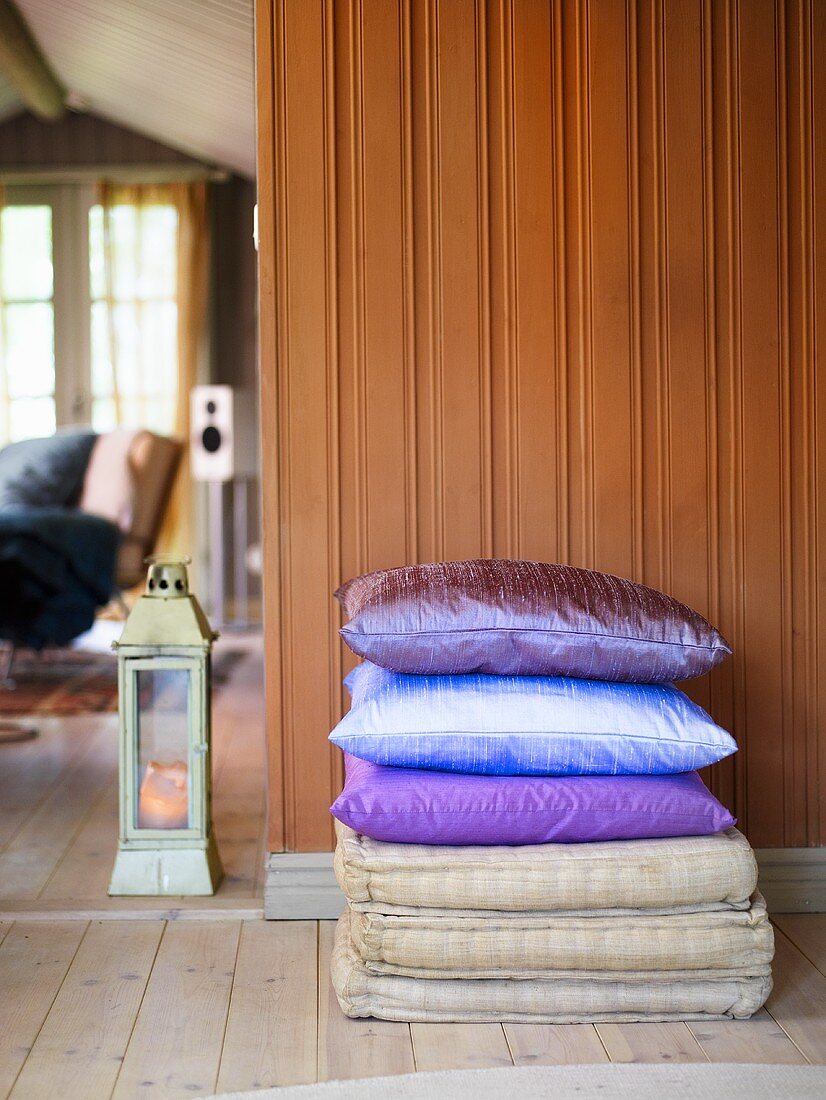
[331,560,773,1022]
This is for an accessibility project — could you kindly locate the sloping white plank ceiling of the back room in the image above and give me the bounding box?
[0,0,255,177]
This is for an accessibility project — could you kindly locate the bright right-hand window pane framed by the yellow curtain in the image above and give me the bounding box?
[89,204,178,435]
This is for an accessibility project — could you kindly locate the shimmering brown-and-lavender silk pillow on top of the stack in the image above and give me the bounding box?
[335,559,731,683]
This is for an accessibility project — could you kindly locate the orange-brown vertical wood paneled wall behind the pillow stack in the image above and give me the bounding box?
[257,0,826,850]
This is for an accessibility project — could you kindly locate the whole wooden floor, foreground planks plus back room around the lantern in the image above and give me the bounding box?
[0,636,826,1100]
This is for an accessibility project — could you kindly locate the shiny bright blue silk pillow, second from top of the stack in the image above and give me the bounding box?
[330,661,737,776]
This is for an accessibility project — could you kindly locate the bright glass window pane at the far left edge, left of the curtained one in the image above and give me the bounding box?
[0,206,56,441]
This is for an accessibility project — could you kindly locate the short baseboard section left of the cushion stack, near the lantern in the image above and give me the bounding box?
[264,851,344,921]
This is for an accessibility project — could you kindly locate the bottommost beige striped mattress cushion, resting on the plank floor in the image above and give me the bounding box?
[331,912,771,1023]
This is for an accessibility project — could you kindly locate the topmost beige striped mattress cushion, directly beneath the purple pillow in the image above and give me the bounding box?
[335,822,757,912]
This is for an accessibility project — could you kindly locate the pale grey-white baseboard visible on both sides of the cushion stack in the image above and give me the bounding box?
[264,848,826,921]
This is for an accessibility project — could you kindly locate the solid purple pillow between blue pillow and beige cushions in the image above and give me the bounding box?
[330,752,735,845]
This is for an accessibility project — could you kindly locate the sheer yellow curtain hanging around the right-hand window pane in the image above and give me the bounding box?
[99,183,209,554]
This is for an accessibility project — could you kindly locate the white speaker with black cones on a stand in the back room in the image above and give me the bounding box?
[189,386,257,482]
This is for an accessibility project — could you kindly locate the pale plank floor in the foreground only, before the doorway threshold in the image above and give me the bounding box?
[0,915,826,1100]
